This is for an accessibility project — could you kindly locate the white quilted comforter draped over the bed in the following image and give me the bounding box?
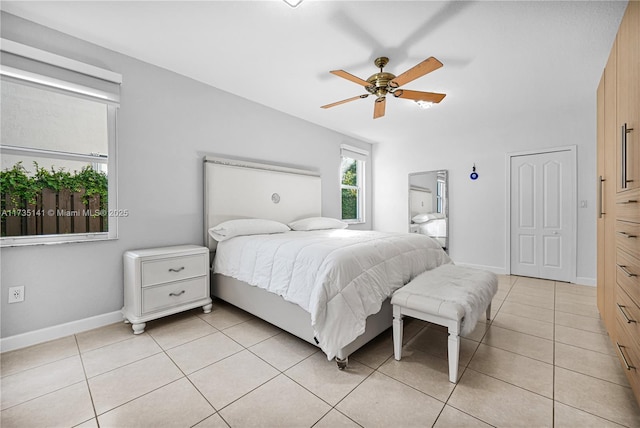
[214,230,451,359]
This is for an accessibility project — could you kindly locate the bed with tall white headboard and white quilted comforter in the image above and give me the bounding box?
[204,157,450,368]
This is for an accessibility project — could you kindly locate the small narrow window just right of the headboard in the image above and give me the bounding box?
[340,145,368,223]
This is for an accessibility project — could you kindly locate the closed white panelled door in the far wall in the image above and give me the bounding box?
[511,150,575,282]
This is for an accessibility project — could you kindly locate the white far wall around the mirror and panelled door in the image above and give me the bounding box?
[373,95,597,285]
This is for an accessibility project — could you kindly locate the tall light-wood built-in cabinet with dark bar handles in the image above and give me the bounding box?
[597,1,640,403]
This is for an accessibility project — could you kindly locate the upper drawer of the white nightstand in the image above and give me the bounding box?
[142,254,208,287]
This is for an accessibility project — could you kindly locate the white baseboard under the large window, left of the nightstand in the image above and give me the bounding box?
[0,311,122,352]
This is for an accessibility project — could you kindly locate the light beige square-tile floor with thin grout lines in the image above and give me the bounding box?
[0,276,640,428]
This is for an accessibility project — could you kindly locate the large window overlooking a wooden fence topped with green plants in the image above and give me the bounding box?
[0,40,120,246]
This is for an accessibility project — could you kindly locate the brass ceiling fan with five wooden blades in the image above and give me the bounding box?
[321,56,446,119]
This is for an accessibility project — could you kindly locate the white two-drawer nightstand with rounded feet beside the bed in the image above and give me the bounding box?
[122,245,212,334]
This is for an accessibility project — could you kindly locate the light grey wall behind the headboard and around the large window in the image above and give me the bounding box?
[0,13,372,338]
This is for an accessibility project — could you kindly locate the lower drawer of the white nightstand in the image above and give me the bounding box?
[142,277,209,313]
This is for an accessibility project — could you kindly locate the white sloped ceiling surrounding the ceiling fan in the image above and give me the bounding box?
[1,0,626,143]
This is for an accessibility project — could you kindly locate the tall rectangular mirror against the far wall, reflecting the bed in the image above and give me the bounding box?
[409,169,449,252]
